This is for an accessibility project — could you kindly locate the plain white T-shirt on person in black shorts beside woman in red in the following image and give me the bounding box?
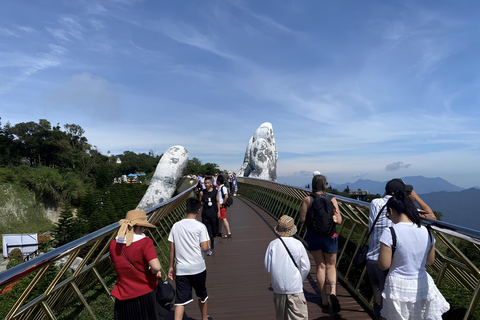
[168,219,210,276]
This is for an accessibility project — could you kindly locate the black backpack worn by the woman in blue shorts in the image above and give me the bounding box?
[307,193,335,237]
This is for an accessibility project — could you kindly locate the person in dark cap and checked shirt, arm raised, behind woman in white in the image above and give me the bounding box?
[367,178,436,320]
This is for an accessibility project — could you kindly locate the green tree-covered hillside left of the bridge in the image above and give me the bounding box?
[0,118,223,248]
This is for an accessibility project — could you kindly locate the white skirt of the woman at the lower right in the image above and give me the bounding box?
[381,273,450,320]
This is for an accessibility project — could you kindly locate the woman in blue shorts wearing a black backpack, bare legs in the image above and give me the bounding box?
[300,174,342,313]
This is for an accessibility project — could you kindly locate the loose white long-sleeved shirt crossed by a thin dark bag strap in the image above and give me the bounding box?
[265,237,310,294]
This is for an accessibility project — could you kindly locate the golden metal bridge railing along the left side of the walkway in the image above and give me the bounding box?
[0,187,194,319]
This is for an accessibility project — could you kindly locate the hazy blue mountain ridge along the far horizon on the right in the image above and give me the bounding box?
[331,176,464,195]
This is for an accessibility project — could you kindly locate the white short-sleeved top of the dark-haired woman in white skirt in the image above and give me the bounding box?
[380,222,435,279]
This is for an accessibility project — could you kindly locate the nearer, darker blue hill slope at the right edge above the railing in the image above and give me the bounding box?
[416,188,480,230]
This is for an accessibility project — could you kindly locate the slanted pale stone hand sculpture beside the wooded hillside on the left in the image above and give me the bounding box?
[137,146,188,211]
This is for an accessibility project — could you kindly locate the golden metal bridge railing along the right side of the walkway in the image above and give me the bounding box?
[237,177,480,320]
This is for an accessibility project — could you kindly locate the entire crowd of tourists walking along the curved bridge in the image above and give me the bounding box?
[110,172,449,320]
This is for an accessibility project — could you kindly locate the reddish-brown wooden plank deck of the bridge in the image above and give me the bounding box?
[166,197,372,320]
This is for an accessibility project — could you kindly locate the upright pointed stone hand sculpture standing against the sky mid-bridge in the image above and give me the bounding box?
[238,122,278,181]
